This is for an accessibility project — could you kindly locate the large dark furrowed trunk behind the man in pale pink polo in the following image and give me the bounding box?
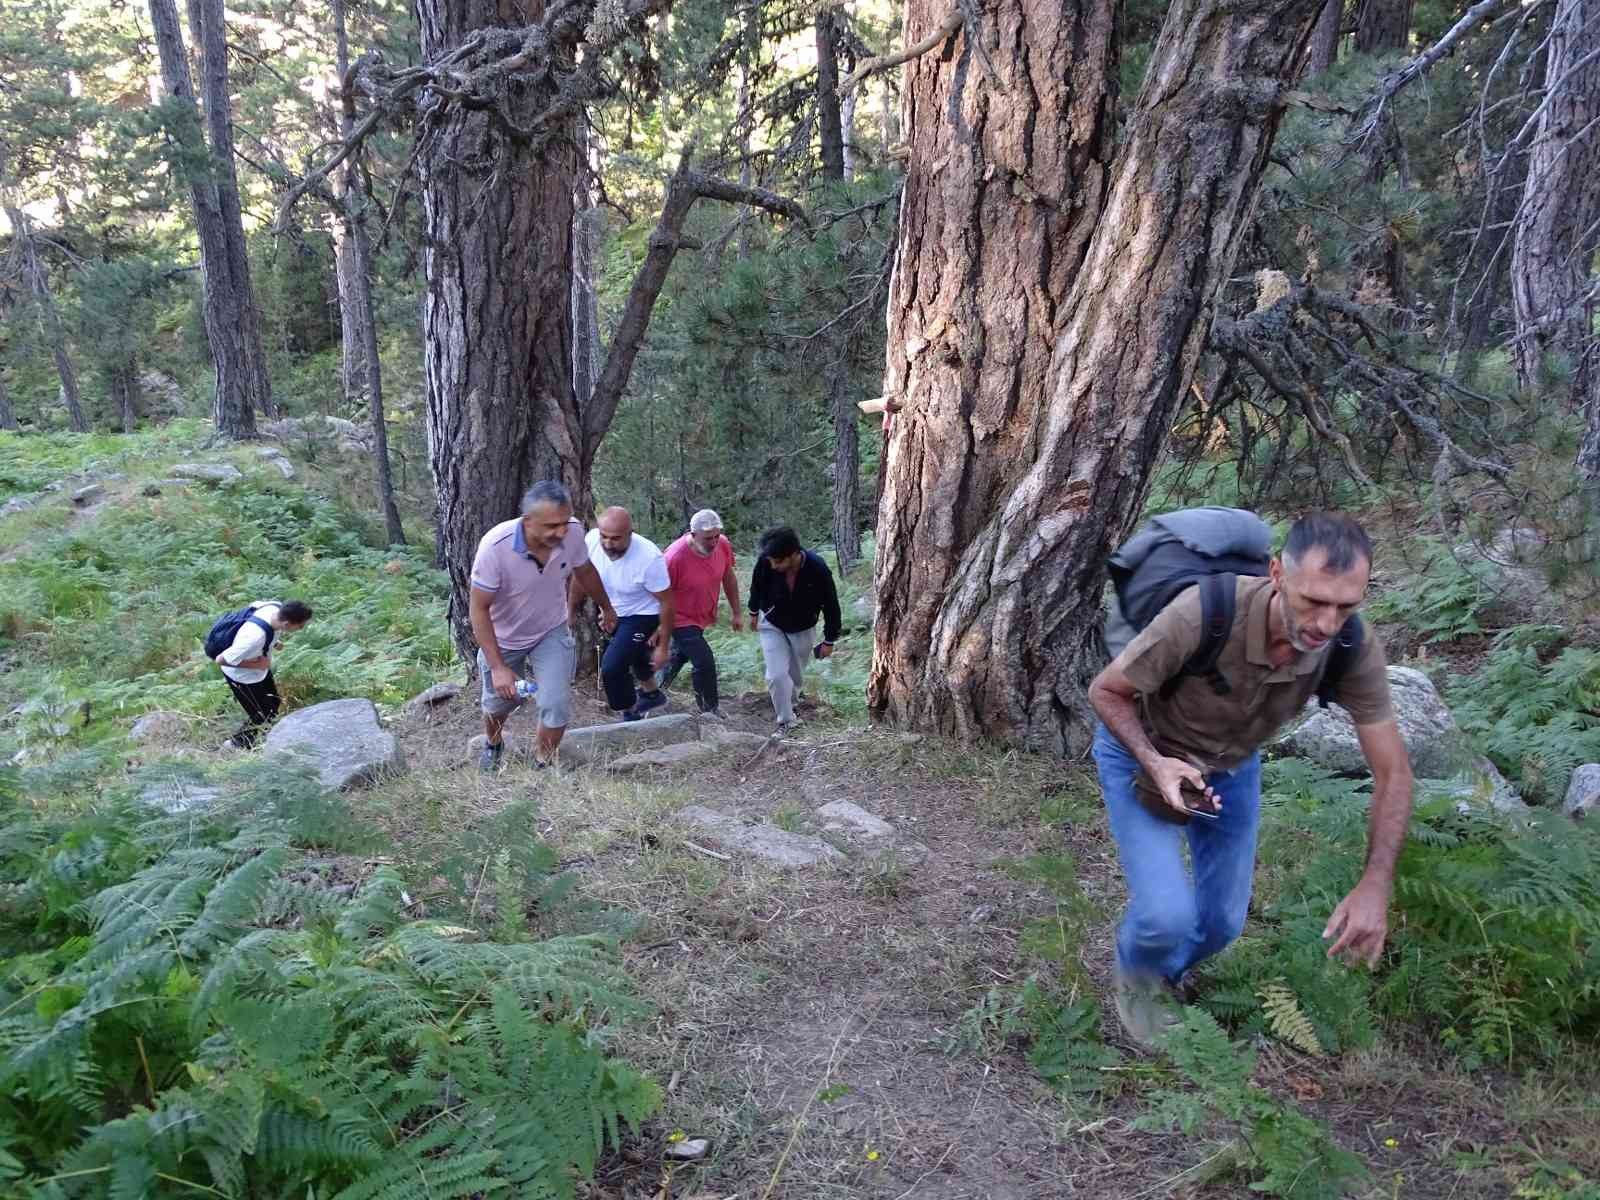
[416,0,594,653]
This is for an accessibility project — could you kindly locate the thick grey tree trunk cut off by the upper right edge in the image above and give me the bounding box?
[1510,0,1600,424]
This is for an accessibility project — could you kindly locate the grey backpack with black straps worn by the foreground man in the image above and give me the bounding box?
[1106,506,1366,707]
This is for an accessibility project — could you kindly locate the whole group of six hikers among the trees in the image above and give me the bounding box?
[206,482,1411,1048]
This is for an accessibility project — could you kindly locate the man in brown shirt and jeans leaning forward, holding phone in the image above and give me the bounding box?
[1090,514,1411,1046]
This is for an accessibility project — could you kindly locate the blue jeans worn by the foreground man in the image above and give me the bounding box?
[1094,725,1261,982]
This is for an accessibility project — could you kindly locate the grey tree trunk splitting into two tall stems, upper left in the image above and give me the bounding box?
[150,0,274,438]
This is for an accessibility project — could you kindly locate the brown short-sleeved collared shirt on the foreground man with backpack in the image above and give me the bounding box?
[1117,576,1394,771]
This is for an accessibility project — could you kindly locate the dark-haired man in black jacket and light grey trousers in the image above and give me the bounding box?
[749,525,840,730]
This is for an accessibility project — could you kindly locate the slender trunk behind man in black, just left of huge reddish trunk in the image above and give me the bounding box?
[816,8,861,571]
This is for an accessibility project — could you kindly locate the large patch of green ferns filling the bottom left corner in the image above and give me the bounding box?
[0,774,659,1200]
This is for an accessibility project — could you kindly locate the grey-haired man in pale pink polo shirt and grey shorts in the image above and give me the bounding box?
[470,482,616,771]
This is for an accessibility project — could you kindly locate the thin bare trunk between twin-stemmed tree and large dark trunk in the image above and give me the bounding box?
[333,0,405,546]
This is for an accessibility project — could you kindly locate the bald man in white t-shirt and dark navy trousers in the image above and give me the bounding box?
[587,509,677,722]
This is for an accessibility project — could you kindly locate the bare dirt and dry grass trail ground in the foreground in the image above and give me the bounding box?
[344,686,1600,1200]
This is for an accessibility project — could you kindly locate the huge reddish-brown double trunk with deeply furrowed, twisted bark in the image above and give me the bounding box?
[869,0,1322,752]
